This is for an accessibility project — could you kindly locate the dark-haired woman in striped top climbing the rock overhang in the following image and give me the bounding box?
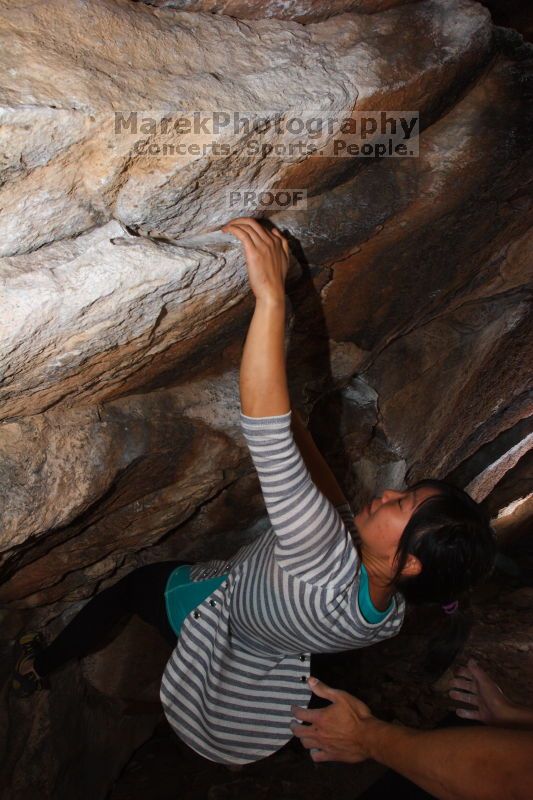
[11,218,495,764]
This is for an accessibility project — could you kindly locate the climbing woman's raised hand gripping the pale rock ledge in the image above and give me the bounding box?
[221,217,289,302]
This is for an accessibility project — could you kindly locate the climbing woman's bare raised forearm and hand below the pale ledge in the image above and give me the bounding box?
[222,217,290,417]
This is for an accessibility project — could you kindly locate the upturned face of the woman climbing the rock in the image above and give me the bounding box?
[354,486,440,566]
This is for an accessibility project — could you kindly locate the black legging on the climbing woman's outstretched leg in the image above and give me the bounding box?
[35,561,188,677]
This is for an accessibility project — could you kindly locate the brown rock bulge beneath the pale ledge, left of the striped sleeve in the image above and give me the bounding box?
[0,384,242,605]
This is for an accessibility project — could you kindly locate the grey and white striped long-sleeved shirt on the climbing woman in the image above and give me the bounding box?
[160,412,405,764]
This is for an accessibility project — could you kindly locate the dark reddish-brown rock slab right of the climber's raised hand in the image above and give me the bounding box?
[275,54,532,488]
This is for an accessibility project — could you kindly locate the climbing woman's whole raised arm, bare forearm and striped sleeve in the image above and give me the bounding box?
[224,218,353,585]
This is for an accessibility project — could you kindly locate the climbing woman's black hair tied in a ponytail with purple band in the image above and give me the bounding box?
[392,479,496,677]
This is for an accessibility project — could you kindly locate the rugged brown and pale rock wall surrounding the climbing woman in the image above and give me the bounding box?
[0,0,533,800]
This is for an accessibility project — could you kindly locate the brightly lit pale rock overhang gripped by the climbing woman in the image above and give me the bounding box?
[0,0,490,419]
